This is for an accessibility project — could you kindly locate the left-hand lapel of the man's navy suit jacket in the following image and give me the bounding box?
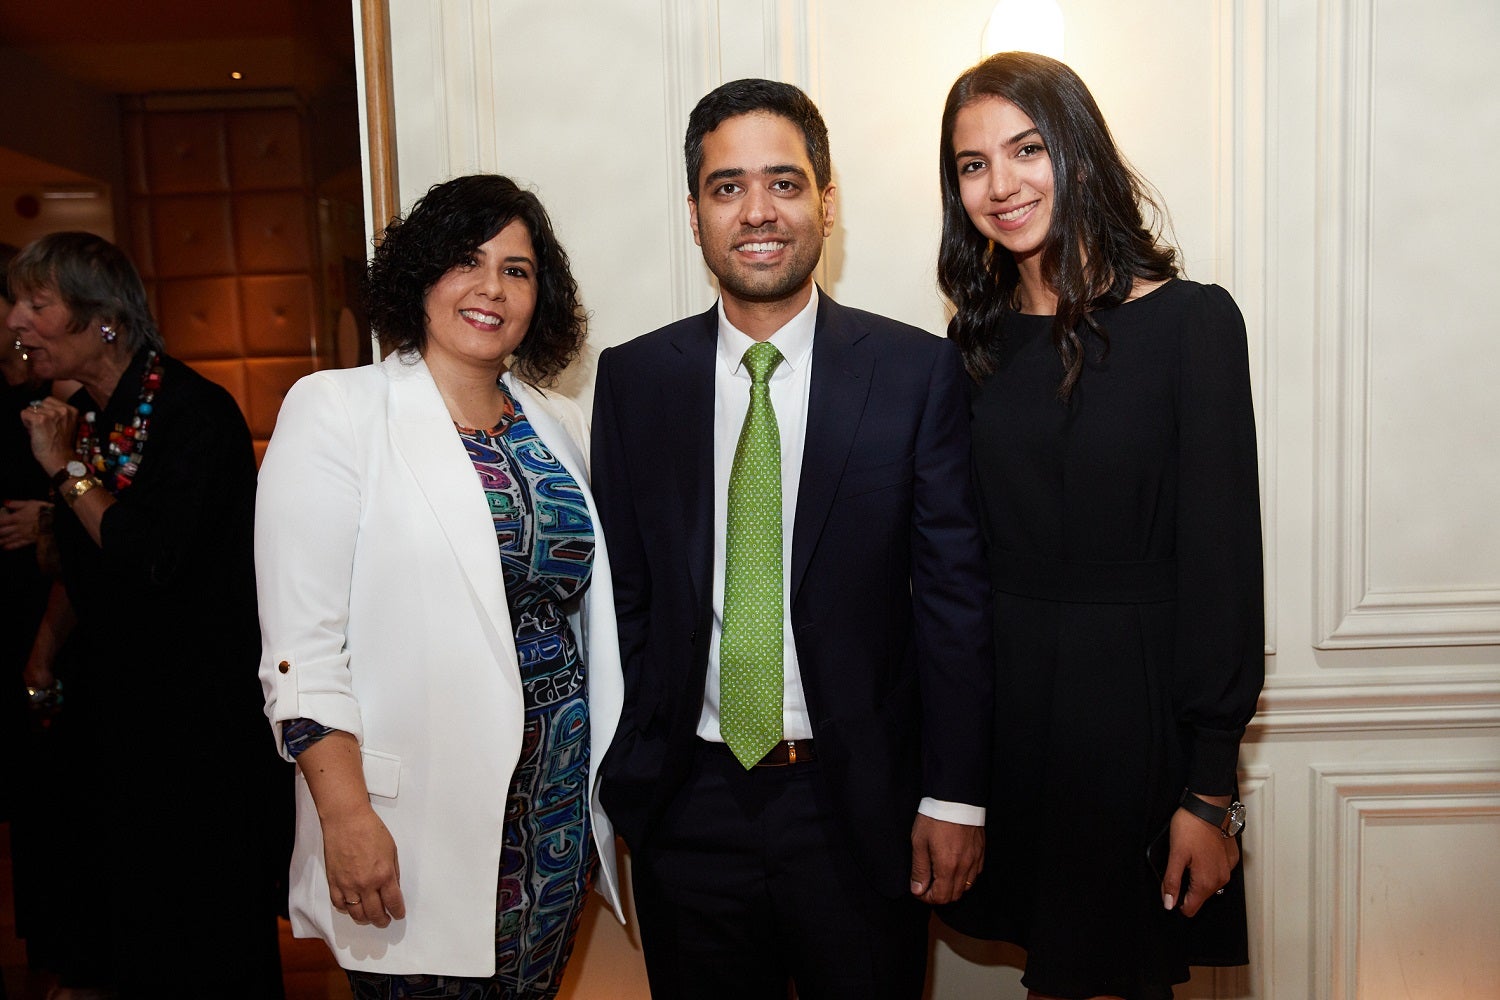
[660,306,719,614]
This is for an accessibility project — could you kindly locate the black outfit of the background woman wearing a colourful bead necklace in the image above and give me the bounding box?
[47,351,291,999]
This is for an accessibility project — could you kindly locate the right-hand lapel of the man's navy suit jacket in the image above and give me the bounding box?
[791,294,875,601]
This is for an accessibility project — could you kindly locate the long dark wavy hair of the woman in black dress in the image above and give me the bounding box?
[938,52,1178,400]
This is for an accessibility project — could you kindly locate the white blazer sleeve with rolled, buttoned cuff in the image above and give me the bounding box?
[255,375,363,756]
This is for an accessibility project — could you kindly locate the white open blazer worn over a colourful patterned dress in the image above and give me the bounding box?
[255,354,624,978]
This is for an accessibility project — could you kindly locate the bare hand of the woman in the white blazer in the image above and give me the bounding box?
[323,802,407,927]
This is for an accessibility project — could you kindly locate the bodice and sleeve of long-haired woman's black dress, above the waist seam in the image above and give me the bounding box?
[974,280,1265,795]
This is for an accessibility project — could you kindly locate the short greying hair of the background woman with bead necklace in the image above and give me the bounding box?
[6,232,162,354]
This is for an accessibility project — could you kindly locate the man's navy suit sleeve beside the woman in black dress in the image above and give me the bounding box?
[912,340,995,805]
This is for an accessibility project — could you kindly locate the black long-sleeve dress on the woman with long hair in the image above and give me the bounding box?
[944,279,1265,999]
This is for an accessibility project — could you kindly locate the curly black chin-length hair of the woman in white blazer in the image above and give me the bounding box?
[365,174,588,385]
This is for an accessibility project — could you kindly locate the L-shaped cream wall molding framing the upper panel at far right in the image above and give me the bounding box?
[1314,0,1500,649]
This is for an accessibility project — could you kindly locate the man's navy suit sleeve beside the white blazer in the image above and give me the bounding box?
[590,349,651,733]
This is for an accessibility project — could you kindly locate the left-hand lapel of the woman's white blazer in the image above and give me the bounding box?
[381,354,510,636]
